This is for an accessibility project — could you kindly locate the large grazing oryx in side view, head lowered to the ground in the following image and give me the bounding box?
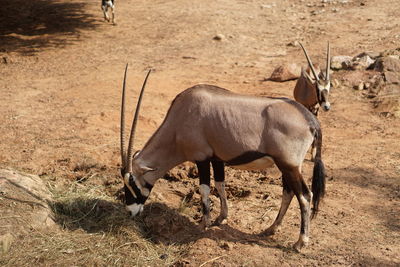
[120,66,325,250]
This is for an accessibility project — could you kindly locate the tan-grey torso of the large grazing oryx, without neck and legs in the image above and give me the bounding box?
[168,85,319,164]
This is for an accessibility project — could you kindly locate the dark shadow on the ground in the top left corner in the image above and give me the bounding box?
[0,0,96,54]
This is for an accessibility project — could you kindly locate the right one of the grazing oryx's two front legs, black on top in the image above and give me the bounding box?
[211,161,228,225]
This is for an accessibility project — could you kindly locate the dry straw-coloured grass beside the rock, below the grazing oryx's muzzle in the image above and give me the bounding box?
[0,183,187,266]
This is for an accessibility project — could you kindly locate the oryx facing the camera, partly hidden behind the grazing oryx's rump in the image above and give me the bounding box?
[293,42,331,116]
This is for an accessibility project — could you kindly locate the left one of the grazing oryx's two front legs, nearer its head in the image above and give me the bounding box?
[196,160,211,229]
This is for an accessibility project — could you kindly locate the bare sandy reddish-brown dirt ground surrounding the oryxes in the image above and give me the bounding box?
[0,0,400,266]
